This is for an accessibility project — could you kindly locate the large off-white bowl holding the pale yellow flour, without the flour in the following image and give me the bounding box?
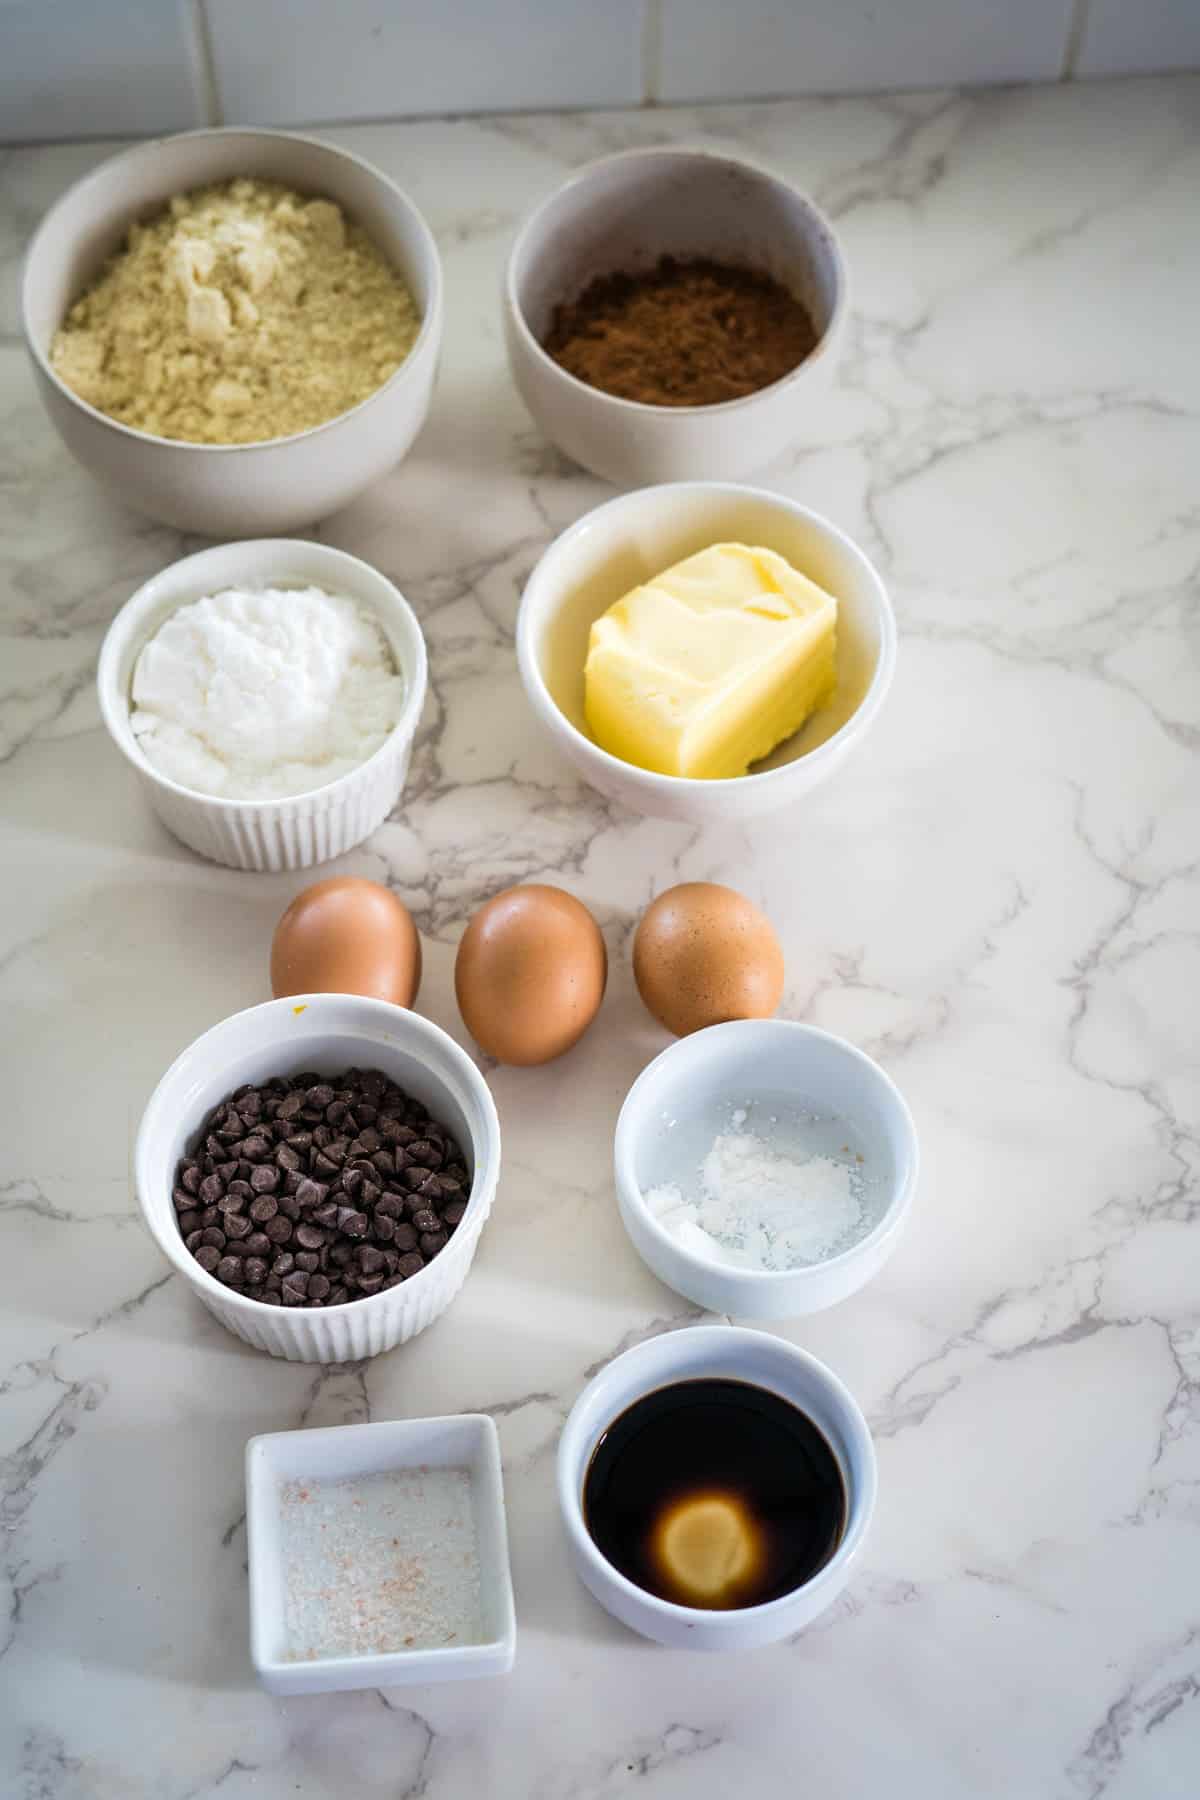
[22,130,443,538]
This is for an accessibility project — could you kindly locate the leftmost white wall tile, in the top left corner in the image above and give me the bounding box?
[0,0,205,144]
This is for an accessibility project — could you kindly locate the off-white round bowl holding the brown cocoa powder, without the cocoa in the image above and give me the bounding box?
[504,148,849,486]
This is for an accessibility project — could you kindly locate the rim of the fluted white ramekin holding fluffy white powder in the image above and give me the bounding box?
[95,538,428,814]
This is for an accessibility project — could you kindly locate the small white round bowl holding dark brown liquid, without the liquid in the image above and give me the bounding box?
[558,1325,876,1651]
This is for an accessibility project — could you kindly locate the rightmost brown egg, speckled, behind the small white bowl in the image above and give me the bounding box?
[633,882,783,1037]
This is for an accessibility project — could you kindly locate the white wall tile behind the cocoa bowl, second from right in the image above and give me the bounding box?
[658,0,1070,101]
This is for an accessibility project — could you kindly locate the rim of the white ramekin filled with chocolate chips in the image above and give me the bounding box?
[133,994,500,1317]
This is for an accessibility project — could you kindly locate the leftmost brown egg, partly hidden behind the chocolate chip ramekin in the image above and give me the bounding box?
[272,875,421,1006]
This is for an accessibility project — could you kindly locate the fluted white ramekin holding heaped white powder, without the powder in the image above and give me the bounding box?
[95,538,426,869]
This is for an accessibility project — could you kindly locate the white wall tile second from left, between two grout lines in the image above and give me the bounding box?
[207,0,642,124]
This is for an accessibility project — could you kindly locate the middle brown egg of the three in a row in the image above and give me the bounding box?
[453,882,608,1066]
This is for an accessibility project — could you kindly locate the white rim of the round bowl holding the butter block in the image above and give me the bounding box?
[516,481,896,794]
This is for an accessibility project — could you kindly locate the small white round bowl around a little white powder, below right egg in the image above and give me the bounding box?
[613,1019,918,1319]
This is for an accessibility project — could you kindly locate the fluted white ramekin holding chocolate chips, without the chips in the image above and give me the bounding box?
[133,994,500,1363]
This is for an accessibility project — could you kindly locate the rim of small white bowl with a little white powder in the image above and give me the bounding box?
[612,1019,919,1292]
